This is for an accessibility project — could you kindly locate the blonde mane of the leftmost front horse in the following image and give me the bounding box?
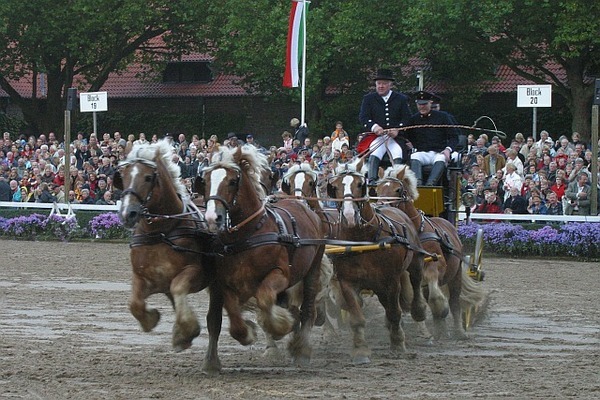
[119,139,189,198]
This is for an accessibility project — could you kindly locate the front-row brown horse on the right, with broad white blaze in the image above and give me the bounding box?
[196,146,325,372]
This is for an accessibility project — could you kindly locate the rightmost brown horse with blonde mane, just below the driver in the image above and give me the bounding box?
[376,165,484,339]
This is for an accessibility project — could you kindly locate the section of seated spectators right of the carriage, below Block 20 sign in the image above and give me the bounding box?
[462,130,600,215]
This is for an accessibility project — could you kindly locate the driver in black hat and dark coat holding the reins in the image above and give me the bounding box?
[359,69,410,185]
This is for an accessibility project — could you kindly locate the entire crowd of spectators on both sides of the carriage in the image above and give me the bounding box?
[0,124,593,215]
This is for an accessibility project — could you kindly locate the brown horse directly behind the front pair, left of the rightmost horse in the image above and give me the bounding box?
[327,159,427,364]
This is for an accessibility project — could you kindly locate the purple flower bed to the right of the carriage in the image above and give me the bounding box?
[458,222,600,259]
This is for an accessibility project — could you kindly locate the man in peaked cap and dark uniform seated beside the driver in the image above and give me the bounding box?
[406,91,458,186]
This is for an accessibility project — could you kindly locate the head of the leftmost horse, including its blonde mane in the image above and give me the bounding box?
[113,140,186,228]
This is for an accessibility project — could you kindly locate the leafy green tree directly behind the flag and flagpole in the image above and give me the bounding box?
[198,0,410,136]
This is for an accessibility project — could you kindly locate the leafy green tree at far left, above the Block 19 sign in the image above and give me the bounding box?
[0,0,205,136]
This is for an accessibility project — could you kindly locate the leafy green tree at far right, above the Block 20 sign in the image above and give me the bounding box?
[406,0,600,142]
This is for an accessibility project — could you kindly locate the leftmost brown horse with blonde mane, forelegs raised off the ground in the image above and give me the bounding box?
[114,140,214,351]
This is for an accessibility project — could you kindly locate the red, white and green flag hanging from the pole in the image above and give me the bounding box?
[283,0,308,88]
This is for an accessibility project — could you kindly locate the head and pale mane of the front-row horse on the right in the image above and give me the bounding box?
[202,146,268,233]
